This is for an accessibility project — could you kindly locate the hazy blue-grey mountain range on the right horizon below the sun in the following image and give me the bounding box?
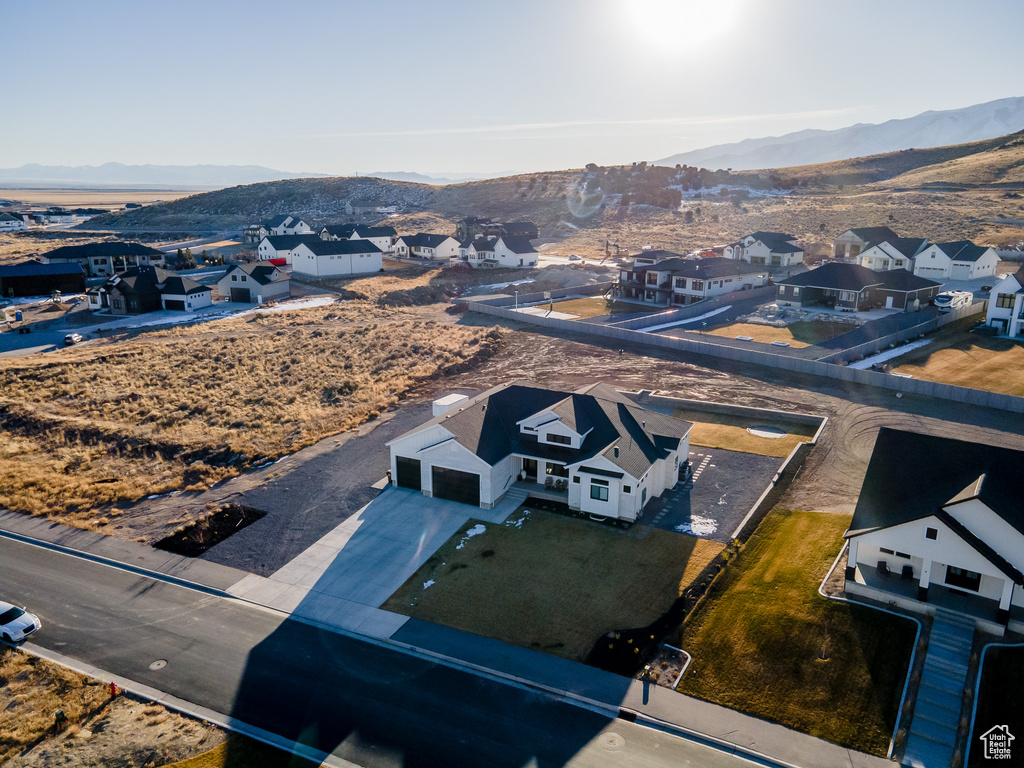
[654,96,1024,171]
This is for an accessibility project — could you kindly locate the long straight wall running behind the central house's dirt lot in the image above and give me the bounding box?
[469,301,1024,414]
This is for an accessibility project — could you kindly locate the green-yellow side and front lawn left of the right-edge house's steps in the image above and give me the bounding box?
[679,510,916,755]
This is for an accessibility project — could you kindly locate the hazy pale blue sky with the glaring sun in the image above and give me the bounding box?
[0,0,1024,175]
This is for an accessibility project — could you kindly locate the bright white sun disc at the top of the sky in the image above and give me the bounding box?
[620,0,739,53]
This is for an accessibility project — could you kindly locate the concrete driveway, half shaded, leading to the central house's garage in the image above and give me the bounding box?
[228,486,519,638]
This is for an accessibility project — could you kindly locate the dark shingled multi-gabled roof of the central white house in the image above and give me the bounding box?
[398,382,693,478]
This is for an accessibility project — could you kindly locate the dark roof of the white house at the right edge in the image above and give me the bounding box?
[847,427,1024,536]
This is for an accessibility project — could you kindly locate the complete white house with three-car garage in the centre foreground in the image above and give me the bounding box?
[387,382,693,522]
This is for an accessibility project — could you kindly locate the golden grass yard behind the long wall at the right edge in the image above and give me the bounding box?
[893,329,1024,397]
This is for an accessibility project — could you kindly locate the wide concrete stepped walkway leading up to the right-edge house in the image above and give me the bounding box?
[903,608,975,768]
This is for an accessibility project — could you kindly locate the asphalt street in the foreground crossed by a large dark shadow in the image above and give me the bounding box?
[0,540,749,768]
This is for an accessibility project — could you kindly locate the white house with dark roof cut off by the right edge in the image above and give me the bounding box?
[845,427,1024,635]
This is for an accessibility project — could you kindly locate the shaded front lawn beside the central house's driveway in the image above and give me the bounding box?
[383,510,723,662]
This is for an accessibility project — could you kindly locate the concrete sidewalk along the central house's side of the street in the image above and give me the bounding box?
[0,511,893,768]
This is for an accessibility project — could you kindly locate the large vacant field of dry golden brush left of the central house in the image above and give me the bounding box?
[0,302,500,524]
